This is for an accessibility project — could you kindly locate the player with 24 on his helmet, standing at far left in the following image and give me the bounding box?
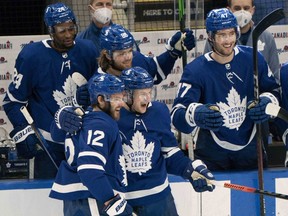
[3,3,97,178]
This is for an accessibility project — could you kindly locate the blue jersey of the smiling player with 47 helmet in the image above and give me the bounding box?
[171,46,279,151]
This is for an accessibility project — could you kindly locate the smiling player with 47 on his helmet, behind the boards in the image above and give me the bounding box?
[171,8,279,170]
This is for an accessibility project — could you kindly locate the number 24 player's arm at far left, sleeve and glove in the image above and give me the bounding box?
[3,48,39,159]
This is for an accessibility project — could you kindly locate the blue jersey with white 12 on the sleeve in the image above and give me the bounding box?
[50,111,127,202]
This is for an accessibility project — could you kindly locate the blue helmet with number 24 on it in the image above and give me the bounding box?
[44,3,76,32]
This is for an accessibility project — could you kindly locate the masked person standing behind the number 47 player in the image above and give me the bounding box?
[204,0,280,82]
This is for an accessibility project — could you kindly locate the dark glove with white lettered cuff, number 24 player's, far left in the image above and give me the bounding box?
[10,125,39,159]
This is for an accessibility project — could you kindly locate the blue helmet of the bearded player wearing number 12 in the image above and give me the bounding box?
[88,74,124,104]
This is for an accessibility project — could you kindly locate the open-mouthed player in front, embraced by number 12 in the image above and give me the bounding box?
[118,67,214,216]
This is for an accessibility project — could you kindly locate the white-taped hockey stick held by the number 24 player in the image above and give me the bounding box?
[20,106,58,170]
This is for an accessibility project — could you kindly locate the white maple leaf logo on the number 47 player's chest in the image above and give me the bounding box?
[216,87,247,130]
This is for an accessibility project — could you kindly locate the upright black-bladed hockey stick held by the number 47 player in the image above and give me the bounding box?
[252,8,285,216]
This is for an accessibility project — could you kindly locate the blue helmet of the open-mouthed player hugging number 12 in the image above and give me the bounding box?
[120,67,153,90]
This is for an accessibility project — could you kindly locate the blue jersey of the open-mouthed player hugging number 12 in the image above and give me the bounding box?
[118,101,191,206]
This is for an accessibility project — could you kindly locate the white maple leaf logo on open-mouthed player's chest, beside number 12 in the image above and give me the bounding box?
[123,131,154,175]
